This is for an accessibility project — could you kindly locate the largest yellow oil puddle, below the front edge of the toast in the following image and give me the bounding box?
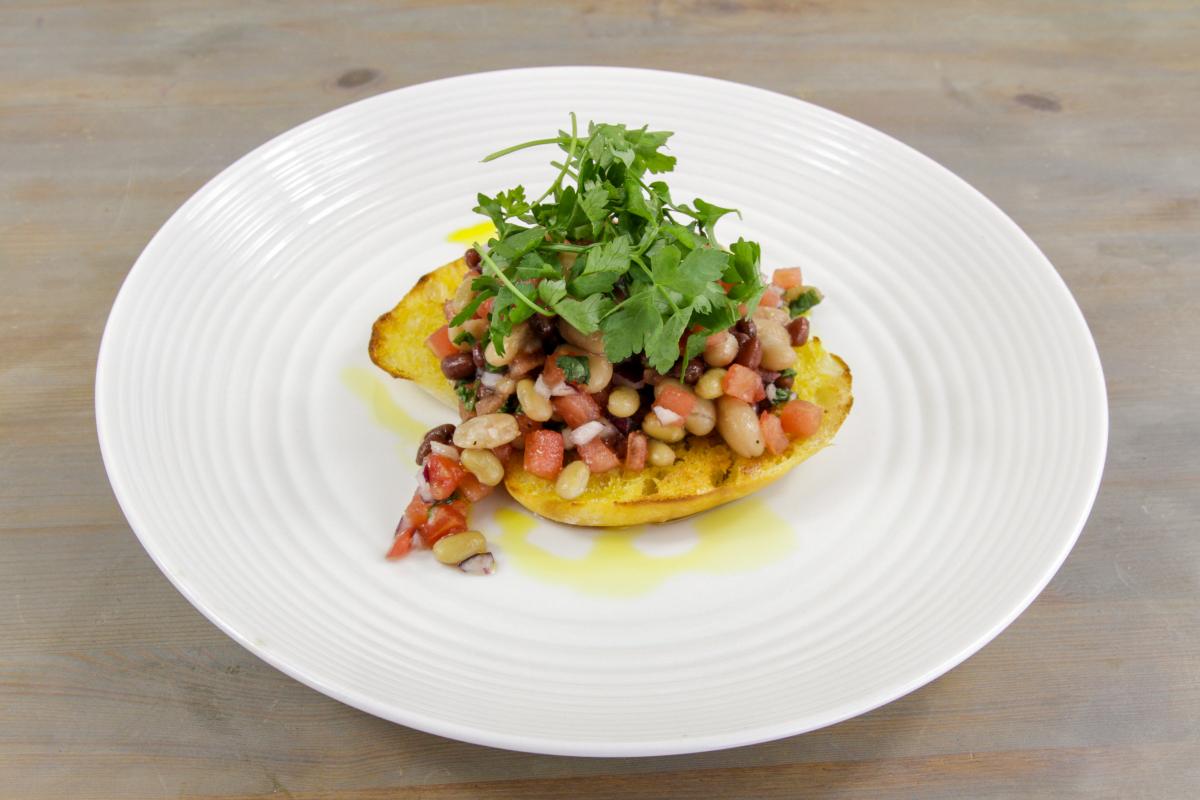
[493,498,796,596]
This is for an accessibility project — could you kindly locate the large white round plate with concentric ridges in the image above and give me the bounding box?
[96,67,1108,756]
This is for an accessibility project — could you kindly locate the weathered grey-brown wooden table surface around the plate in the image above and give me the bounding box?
[0,0,1200,800]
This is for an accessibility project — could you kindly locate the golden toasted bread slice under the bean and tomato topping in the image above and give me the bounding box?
[371,259,853,527]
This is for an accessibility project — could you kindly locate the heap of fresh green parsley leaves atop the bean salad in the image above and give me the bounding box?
[463,114,782,383]
